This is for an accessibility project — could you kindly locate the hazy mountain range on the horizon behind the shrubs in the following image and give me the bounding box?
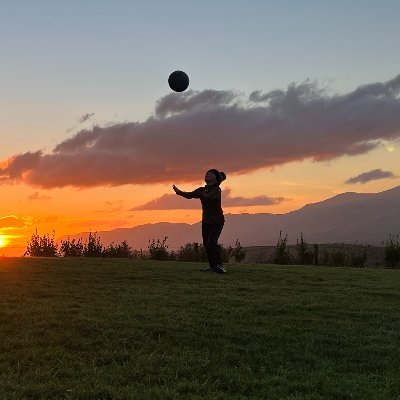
[61,186,400,250]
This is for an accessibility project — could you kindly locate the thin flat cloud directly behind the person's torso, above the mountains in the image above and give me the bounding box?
[129,188,288,211]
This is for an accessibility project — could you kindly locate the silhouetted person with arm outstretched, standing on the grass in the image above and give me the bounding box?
[172,169,226,274]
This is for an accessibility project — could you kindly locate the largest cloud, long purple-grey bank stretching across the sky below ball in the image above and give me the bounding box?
[0,75,400,188]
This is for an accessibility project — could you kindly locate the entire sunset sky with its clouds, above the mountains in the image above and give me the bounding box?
[0,0,400,256]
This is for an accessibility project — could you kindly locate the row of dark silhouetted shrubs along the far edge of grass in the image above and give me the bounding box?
[24,230,400,268]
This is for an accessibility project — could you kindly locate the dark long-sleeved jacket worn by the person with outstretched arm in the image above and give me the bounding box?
[179,184,225,223]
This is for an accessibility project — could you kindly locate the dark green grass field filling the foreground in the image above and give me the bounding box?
[0,258,400,400]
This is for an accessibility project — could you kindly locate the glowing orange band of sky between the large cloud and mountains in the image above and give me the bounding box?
[0,146,400,256]
